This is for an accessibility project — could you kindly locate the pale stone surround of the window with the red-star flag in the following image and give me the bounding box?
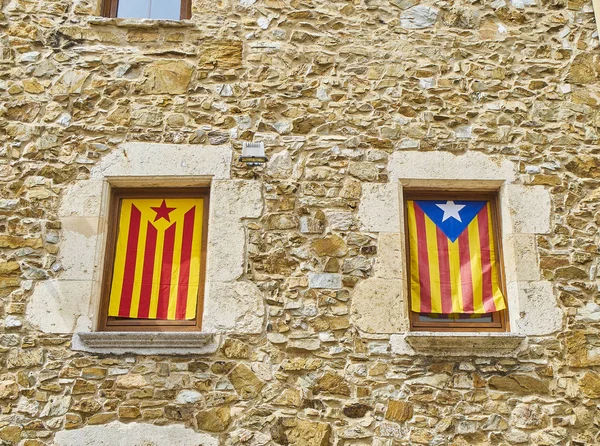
[26,143,265,344]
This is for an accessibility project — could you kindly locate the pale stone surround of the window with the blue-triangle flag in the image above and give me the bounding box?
[351,152,563,354]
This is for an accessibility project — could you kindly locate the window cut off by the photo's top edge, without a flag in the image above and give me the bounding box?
[103,0,192,20]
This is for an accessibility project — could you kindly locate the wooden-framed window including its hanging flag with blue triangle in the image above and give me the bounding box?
[404,190,508,331]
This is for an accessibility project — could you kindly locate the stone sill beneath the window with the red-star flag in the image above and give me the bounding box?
[71,331,219,355]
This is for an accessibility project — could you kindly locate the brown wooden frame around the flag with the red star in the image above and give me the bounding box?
[98,187,210,332]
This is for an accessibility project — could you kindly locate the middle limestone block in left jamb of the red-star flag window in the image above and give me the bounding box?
[59,217,98,280]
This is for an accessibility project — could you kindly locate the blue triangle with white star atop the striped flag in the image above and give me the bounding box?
[415,200,487,243]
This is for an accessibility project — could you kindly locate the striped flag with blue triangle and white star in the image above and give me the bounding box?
[406,200,506,314]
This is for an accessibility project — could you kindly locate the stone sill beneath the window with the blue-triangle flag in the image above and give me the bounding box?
[405,331,526,356]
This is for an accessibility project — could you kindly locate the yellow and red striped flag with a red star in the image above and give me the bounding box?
[108,198,203,320]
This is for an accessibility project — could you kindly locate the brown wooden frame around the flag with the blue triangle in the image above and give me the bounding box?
[403,189,510,332]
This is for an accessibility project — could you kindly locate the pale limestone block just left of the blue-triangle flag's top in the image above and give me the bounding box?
[358,182,400,232]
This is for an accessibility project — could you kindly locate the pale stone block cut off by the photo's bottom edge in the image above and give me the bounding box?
[54,421,219,446]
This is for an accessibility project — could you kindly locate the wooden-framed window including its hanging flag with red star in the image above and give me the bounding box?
[99,188,209,331]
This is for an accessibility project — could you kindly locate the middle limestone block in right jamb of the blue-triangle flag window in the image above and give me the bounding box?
[502,234,541,282]
